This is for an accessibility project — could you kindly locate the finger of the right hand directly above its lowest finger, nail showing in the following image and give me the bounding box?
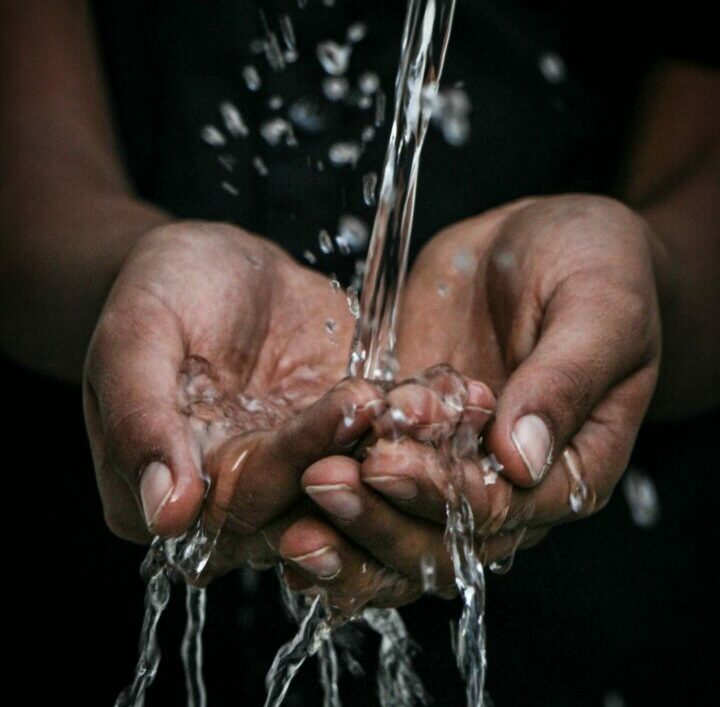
[302,457,453,586]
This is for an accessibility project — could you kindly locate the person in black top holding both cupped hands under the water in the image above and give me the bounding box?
[0,0,720,707]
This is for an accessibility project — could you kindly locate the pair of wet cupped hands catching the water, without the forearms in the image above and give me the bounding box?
[85,196,660,608]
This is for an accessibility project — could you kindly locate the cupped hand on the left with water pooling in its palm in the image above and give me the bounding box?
[83,222,381,574]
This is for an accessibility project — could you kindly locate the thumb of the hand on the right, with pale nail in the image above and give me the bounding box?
[485,277,657,486]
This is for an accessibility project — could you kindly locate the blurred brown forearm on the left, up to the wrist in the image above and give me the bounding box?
[0,0,165,379]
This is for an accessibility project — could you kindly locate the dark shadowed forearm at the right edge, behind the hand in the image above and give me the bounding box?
[621,62,720,418]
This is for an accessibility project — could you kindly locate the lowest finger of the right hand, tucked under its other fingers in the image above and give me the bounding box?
[279,516,421,615]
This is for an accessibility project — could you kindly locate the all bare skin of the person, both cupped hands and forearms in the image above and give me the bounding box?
[0,0,720,611]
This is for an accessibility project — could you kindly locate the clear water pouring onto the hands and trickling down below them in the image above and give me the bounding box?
[116,0,500,707]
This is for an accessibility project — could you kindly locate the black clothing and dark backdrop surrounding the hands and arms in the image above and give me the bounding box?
[1,0,720,707]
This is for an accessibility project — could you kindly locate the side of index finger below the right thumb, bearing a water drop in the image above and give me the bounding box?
[506,371,653,527]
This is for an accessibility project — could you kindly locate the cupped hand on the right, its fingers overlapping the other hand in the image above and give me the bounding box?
[280,195,660,604]
